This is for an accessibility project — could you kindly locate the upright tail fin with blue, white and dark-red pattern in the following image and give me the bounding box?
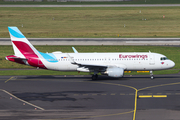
[8,27,38,58]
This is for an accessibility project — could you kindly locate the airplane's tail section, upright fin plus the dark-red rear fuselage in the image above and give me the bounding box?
[5,27,46,69]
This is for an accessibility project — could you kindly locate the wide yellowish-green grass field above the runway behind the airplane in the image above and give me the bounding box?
[0,7,180,38]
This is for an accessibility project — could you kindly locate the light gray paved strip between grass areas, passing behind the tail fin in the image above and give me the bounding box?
[0,38,180,45]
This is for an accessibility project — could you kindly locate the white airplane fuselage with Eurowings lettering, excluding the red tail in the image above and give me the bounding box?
[40,52,175,72]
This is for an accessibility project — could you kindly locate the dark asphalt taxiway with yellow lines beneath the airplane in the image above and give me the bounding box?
[0,74,180,120]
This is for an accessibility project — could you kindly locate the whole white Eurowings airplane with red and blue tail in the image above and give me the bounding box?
[5,27,175,80]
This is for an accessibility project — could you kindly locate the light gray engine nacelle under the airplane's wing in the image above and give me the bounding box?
[106,67,124,77]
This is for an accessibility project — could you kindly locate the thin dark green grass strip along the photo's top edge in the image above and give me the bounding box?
[0,0,180,5]
